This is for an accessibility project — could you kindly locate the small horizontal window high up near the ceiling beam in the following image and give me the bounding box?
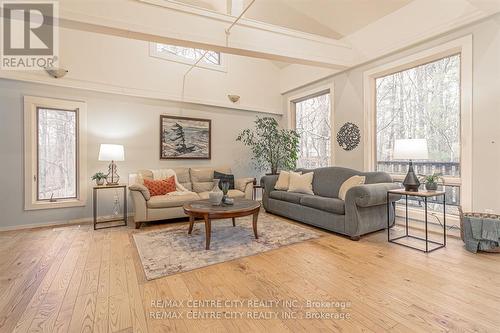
[150,43,223,70]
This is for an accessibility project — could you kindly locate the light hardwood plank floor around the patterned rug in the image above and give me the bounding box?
[0,213,500,332]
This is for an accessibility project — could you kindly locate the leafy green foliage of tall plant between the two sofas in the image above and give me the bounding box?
[236,117,299,175]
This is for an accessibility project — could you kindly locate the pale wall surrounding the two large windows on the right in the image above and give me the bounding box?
[283,14,500,213]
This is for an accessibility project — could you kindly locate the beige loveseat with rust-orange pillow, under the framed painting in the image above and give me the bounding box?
[129,167,254,229]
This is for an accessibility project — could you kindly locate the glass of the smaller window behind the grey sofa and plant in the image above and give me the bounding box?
[294,92,332,168]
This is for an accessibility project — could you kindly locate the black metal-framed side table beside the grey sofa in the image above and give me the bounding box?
[387,189,446,253]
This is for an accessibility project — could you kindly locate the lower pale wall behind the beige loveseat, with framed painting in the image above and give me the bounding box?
[0,79,274,229]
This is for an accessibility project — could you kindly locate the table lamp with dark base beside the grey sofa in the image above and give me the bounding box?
[392,139,429,192]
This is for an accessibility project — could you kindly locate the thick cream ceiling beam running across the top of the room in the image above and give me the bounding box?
[59,0,355,69]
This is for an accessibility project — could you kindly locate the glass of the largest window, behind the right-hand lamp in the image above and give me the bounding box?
[375,54,461,211]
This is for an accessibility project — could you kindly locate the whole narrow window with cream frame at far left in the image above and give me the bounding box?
[24,96,87,209]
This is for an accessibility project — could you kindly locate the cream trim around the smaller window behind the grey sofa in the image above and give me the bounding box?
[286,83,337,166]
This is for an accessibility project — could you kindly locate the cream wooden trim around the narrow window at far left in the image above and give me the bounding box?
[24,96,88,210]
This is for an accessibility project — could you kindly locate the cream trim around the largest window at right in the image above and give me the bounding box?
[363,35,473,211]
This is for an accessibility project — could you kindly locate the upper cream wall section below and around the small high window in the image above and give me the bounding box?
[0,28,282,114]
